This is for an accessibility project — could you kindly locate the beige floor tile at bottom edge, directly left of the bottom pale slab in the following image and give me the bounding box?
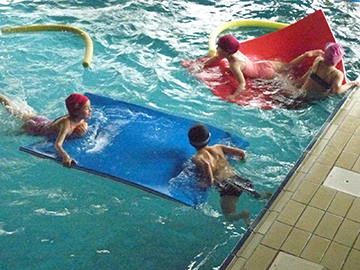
[243,245,277,270]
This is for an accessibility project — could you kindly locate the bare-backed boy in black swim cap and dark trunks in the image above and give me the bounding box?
[188,124,268,225]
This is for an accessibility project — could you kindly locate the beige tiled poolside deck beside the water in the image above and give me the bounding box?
[226,85,360,270]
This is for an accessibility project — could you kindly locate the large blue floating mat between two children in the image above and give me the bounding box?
[20,93,248,208]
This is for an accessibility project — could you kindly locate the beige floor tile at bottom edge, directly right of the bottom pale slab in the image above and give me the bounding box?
[321,242,350,270]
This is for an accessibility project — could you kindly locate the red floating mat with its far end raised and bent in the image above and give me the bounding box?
[182,10,345,109]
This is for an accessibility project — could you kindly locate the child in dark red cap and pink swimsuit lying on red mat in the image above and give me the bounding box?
[204,35,322,99]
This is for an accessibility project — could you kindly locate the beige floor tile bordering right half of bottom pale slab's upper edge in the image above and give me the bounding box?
[301,235,330,263]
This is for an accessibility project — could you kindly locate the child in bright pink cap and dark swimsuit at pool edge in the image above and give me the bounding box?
[291,42,360,100]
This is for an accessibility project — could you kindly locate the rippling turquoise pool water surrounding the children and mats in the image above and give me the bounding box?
[0,0,360,270]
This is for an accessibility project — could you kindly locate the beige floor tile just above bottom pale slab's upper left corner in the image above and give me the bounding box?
[261,221,292,249]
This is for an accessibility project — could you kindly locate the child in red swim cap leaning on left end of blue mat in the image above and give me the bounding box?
[0,94,92,167]
